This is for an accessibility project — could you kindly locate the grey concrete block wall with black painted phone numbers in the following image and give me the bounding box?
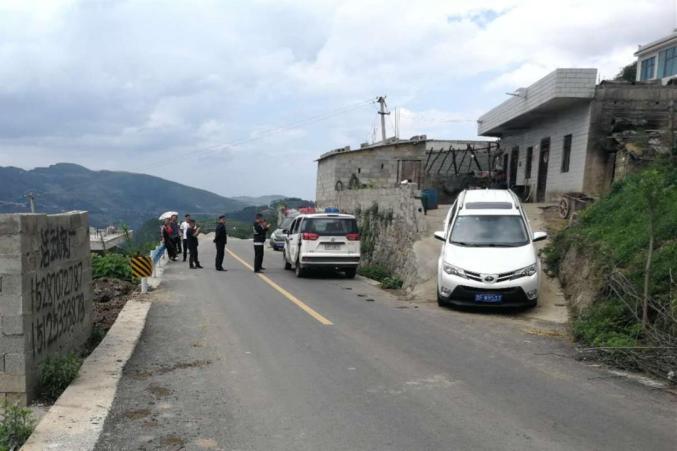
[0,212,92,404]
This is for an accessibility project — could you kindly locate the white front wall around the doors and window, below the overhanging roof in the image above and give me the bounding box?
[501,102,591,201]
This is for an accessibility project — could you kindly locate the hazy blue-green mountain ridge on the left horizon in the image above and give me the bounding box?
[0,163,247,228]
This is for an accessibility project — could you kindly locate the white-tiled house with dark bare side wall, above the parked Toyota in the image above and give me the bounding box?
[478,69,677,202]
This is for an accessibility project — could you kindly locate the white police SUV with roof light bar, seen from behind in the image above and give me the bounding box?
[283,213,360,278]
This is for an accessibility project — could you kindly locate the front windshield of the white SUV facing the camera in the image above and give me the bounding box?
[449,215,529,247]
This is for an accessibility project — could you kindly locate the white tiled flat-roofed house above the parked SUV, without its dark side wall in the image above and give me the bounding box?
[478,69,597,201]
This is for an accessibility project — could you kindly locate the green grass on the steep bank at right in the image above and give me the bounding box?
[544,159,677,347]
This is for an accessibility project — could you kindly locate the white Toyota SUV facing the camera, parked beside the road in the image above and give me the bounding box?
[435,190,547,307]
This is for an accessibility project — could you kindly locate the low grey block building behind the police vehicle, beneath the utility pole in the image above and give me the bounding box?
[316,135,497,207]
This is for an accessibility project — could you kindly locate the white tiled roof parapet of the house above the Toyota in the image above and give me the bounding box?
[477,69,597,135]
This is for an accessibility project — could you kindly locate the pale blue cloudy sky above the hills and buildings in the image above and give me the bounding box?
[0,0,677,199]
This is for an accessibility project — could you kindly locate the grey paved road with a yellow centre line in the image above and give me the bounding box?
[98,240,677,450]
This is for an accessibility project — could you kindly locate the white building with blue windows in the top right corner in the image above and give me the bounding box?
[635,30,677,84]
